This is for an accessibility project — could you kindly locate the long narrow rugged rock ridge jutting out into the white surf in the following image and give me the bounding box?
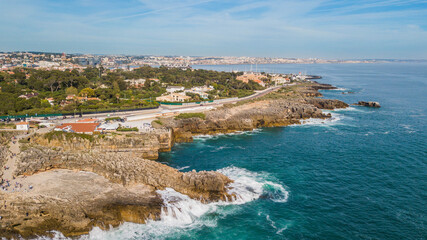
[15,147,231,201]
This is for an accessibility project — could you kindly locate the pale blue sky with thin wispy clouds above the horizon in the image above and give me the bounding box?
[0,0,427,59]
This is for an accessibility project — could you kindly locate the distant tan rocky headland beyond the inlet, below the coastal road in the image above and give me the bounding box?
[162,98,348,142]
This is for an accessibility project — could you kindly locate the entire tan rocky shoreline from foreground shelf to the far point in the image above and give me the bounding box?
[0,83,348,238]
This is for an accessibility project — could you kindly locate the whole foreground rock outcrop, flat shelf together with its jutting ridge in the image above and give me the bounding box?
[0,146,231,237]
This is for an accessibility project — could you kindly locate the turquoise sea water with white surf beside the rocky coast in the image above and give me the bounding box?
[81,64,427,239]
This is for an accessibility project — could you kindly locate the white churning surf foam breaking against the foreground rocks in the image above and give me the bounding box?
[77,167,289,240]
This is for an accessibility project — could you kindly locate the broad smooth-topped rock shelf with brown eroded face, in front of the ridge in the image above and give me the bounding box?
[0,170,162,238]
